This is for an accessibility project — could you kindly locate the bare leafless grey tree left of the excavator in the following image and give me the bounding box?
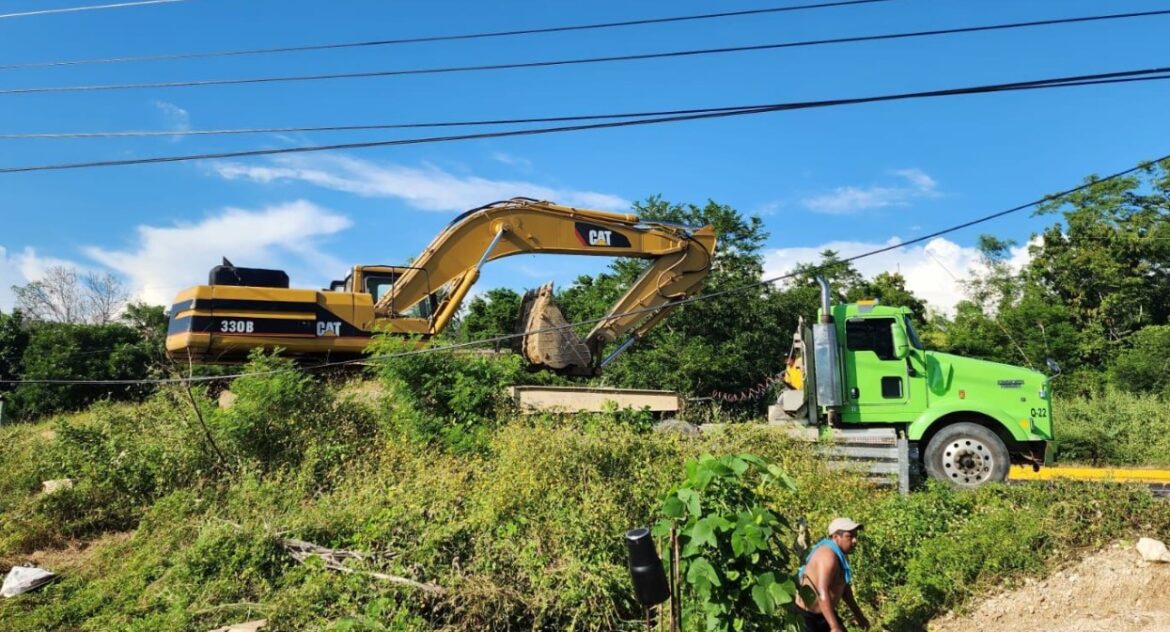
[12,266,130,324]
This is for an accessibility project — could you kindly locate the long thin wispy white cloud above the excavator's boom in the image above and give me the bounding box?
[213,156,629,212]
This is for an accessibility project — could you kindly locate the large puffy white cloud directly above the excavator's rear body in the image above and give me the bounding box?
[84,200,350,305]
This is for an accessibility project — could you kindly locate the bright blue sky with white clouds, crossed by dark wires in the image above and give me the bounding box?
[0,0,1170,310]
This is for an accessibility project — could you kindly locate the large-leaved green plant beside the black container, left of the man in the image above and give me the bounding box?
[654,454,798,631]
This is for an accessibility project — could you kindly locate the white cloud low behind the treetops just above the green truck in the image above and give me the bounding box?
[764,238,1031,314]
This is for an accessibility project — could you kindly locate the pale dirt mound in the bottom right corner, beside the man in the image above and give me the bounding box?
[929,543,1170,632]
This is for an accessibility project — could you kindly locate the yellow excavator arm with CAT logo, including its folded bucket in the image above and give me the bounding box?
[374,198,716,375]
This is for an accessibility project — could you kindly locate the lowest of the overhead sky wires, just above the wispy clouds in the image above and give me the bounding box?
[0,67,1170,173]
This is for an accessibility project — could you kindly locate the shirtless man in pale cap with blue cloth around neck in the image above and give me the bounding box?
[797,517,869,632]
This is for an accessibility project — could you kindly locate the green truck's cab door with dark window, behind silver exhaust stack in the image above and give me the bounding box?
[842,317,911,423]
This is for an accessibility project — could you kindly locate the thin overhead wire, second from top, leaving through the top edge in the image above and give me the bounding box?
[0,0,890,70]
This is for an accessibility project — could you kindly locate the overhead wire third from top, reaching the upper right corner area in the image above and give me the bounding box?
[0,9,1170,95]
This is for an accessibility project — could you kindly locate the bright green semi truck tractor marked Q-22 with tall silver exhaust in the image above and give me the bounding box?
[770,279,1053,487]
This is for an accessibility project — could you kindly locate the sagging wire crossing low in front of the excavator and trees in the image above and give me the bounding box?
[0,154,1170,386]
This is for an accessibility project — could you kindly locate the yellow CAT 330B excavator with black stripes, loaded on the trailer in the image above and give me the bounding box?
[166,198,716,375]
